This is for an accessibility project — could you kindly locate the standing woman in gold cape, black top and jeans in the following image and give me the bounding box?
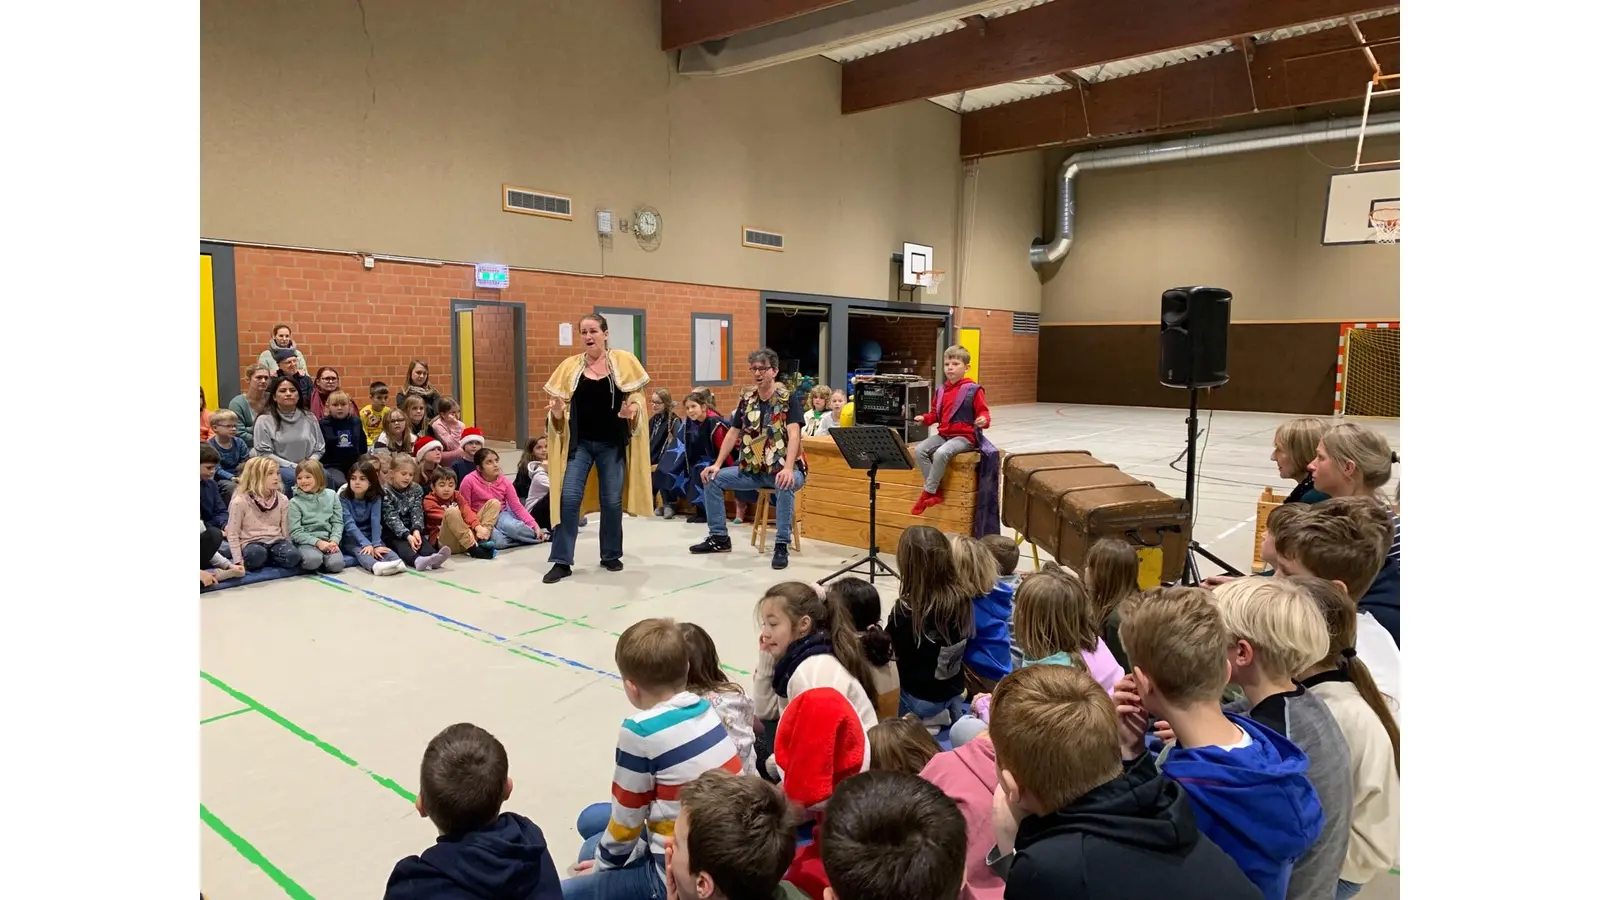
[544,312,651,585]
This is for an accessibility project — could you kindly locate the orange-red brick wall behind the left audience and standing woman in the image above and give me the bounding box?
[234,247,760,432]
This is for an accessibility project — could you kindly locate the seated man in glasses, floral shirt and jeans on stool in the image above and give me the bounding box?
[690,348,805,569]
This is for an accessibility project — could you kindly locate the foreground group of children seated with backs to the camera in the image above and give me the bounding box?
[387,480,1400,900]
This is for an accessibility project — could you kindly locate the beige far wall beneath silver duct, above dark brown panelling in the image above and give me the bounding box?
[1040,138,1400,322]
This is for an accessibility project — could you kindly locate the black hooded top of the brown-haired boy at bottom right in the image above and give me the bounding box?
[1005,754,1261,900]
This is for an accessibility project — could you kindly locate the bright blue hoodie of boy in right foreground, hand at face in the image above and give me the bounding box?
[1162,714,1322,900]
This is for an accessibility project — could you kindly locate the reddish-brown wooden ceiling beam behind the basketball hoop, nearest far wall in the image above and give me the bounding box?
[962,16,1400,159]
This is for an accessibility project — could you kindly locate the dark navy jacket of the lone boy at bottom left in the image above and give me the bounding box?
[384,812,562,900]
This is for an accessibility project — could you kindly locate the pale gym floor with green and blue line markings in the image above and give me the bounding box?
[200,404,1398,900]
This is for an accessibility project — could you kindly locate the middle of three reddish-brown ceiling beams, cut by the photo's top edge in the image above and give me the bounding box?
[844,0,1400,114]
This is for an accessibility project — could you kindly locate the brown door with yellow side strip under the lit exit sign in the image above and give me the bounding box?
[450,299,528,447]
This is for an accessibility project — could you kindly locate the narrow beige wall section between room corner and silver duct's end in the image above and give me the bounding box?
[963,151,1046,312]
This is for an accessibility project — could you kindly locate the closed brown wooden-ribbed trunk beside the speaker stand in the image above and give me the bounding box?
[1000,450,1189,583]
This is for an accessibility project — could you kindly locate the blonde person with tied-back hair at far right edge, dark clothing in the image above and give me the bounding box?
[1309,421,1400,647]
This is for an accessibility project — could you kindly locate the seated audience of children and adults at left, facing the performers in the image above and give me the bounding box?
[200,348,550,588]
